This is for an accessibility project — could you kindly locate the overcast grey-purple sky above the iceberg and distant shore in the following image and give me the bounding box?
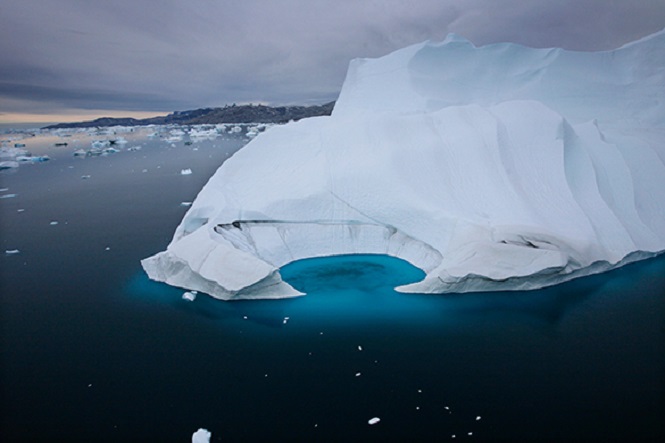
[0,0,665,120]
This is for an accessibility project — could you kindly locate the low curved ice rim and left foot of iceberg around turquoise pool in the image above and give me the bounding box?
[143,219,442,300]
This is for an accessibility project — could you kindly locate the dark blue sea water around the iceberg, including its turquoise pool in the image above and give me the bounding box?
[0,128,665,442]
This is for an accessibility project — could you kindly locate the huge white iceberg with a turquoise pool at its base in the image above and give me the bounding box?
[142,30,665,300]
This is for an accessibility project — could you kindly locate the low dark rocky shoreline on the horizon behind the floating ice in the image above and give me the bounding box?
[42,101,335,129]
